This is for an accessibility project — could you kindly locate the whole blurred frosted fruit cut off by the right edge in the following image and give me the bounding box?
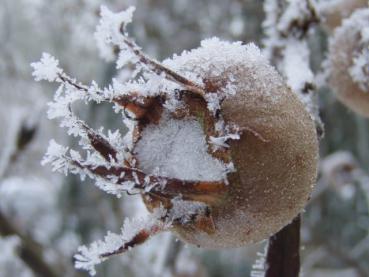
[328,9,369,117]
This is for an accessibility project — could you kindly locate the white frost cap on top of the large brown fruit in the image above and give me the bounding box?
[163,37,268,99]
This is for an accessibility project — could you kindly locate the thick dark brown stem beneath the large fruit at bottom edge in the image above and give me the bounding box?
[265,214,301,277]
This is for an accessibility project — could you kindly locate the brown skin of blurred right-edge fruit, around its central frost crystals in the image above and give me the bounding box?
[328,9,369,117]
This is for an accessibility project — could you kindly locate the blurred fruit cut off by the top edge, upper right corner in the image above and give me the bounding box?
[319,0,368,32]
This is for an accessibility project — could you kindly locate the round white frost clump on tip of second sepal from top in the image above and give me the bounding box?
[31,53,63,82]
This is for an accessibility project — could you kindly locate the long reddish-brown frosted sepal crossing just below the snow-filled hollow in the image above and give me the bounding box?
[42,140,227,198]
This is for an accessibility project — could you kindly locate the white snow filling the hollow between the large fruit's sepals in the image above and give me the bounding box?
[135,114,226,181]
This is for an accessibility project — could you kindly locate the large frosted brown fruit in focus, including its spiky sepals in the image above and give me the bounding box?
[31,7,318,274]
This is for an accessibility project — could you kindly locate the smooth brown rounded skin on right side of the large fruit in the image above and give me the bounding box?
[158,46,318,249]
